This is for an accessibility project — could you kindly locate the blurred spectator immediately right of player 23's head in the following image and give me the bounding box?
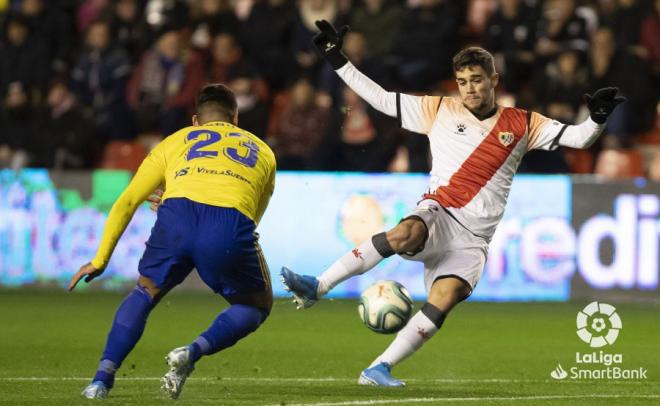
[227,70,268,139]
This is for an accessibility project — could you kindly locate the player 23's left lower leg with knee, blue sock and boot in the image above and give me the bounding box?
[82,276,171,399]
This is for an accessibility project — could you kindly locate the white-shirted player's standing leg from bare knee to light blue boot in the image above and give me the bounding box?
[358,276,472,386]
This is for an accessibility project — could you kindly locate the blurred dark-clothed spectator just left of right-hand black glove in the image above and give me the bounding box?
[535,51,587,124]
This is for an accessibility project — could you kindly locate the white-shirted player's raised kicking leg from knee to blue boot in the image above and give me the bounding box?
[281,217,428,308]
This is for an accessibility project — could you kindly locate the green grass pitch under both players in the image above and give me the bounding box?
[0,290,660,406]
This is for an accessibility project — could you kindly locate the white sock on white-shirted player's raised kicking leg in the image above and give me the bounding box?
[317,238,383,297]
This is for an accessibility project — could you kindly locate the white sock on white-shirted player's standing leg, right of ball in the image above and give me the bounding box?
[369,310,438,368]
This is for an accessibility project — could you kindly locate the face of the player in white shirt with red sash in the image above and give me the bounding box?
[456,66,497,113]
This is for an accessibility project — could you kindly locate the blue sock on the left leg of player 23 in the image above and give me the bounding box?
[93,286,154,388]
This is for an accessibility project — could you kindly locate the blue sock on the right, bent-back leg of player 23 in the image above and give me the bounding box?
[190,304,268,362]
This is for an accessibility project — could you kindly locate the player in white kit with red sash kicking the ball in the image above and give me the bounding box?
[282,21,625,386]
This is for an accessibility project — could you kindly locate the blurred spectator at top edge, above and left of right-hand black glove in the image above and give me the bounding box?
[536,0,589,63]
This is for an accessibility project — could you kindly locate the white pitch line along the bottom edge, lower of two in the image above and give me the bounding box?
[271,394,660,406]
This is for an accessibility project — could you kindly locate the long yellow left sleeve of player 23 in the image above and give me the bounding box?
[92,148,165,269]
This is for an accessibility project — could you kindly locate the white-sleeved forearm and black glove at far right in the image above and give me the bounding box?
[558,87,626,149]
